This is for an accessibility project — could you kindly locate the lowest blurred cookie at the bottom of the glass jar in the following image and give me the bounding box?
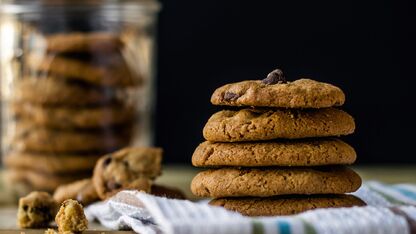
[4,168,91,191]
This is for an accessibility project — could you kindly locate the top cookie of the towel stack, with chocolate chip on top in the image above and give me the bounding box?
[211,70,345,108]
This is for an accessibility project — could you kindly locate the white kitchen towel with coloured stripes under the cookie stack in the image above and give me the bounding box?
[85,181,416,234]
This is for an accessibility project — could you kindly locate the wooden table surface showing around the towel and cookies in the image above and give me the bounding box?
[0,165,416,234]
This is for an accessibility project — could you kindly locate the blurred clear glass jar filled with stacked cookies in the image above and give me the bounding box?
[0,0,159,194]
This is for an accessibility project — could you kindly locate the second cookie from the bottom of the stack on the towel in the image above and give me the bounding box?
[191,166,361,198]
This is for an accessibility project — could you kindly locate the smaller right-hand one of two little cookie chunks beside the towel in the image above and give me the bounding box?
[55,199,88,233]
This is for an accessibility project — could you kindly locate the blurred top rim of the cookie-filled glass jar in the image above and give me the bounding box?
[0,0,160,14]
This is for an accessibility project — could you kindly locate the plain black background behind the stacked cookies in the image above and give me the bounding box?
[156,0,416,164]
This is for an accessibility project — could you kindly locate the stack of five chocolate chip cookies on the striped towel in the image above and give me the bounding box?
[191,69,364,216]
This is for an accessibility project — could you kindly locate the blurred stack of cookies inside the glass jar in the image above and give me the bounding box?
[3,32,141,194]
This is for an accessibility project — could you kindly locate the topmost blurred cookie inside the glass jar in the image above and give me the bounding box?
[45,32,123,53]
